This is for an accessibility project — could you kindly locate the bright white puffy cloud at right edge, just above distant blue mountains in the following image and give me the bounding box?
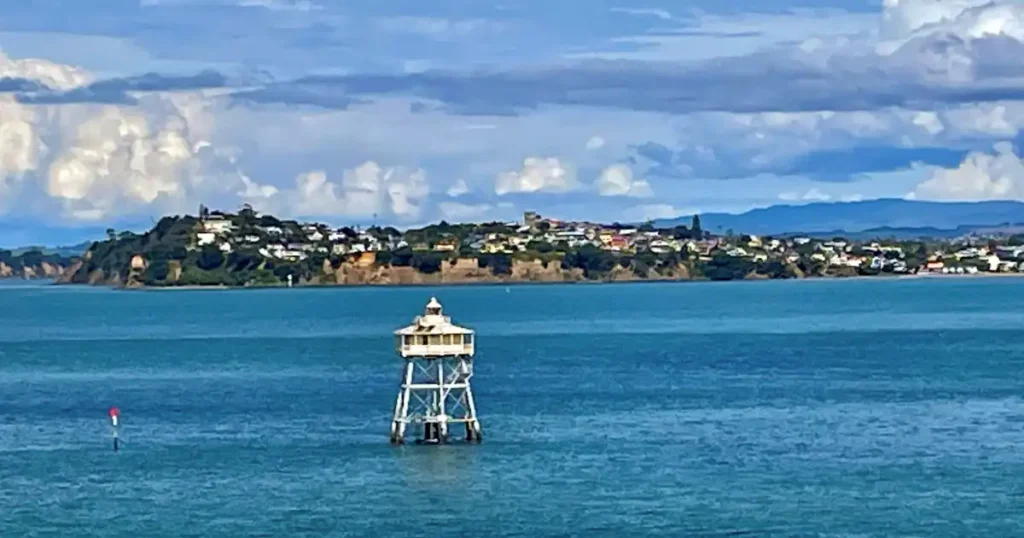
[907,142,1024,202]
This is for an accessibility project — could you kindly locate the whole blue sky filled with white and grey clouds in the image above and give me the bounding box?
[0,0,1024,242]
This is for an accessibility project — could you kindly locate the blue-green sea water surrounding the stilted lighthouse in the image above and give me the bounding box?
[0,279,1024,538]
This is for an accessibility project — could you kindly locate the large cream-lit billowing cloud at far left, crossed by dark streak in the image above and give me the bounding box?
[0,48,238,220]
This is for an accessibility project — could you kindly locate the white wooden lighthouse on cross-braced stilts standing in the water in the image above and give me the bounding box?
[391,297,481,445]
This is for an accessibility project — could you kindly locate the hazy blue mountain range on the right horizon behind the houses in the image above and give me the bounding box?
[654,199,1024,238]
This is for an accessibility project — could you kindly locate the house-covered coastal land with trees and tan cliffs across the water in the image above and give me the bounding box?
[39,206,1024,288]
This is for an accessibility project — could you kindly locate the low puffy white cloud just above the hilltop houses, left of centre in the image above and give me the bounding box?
[249,161,430,220]
